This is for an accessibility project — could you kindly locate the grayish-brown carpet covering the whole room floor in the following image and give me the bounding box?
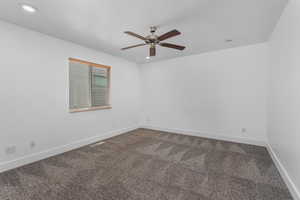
[0,129,292,200]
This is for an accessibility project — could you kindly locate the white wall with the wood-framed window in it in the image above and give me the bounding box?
[0,21,140,167]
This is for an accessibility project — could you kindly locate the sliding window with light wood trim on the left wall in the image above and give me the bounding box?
[69,58,111,112]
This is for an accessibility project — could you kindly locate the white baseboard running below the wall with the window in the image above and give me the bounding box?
[0,126,139,173]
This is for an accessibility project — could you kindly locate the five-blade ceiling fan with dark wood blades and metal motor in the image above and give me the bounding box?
[121,26,185,56]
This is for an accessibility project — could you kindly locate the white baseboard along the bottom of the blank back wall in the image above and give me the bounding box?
[141,125,267,147]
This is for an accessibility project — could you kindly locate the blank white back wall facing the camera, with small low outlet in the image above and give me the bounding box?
[141,44,268,144]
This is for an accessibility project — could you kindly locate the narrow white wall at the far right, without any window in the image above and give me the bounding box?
[268,0,300,199]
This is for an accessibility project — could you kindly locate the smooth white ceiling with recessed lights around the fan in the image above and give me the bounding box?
[0,0,288,63]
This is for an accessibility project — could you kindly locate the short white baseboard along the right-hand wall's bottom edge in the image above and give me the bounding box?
[267,144,300,200]
